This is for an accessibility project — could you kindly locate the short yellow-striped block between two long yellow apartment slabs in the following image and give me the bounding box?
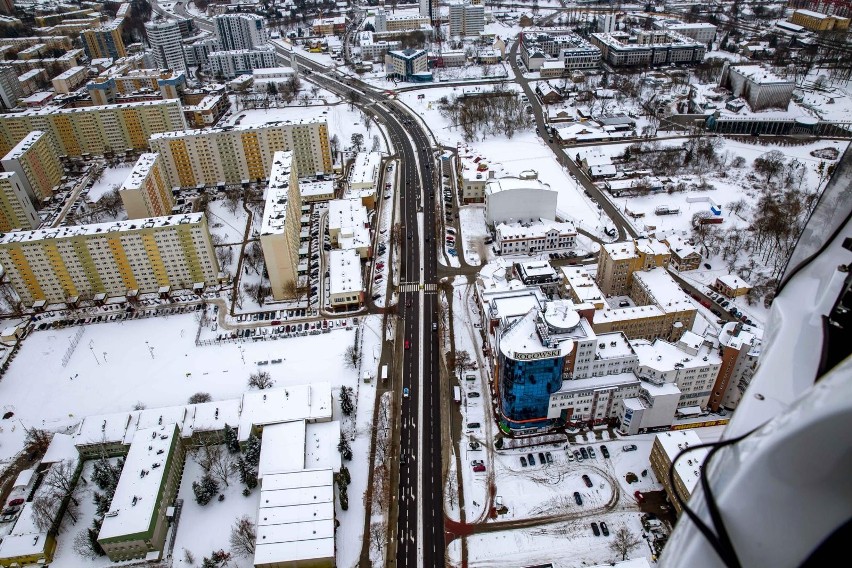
[118,153,174,219]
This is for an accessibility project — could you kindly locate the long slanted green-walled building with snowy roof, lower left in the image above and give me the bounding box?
[98,423,186,562]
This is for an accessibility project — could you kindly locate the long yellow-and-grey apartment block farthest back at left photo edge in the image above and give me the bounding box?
[0,100,186,156]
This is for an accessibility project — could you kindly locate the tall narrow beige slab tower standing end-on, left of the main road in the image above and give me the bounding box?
[260,152,302,300]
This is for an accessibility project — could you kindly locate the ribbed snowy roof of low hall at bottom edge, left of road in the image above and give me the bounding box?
[254,469,335,565]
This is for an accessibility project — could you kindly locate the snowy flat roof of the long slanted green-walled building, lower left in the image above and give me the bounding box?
[98,423,178,540]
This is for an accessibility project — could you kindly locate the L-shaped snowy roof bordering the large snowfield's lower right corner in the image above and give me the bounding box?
[239,382,331,441]
